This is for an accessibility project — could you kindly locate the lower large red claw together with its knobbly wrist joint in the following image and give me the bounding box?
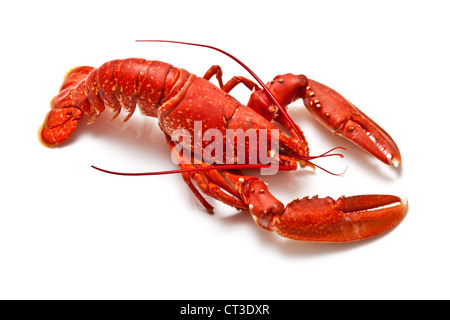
[243,178,407,242]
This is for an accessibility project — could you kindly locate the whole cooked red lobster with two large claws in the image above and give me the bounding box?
[40,45,407,242]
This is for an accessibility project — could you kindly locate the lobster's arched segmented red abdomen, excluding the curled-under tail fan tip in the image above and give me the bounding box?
[52,58,180,117]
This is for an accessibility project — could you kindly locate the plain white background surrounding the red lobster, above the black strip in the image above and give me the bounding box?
[0,0,450,299]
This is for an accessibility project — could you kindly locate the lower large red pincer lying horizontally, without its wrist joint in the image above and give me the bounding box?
[269,195,407,242]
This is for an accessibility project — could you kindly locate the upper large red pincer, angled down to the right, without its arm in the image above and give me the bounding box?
[303,79,401,167]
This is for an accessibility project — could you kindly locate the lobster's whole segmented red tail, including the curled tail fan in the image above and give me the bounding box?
[41,58,189,145]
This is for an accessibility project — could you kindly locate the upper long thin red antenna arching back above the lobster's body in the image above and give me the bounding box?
[136,40,302,139]
